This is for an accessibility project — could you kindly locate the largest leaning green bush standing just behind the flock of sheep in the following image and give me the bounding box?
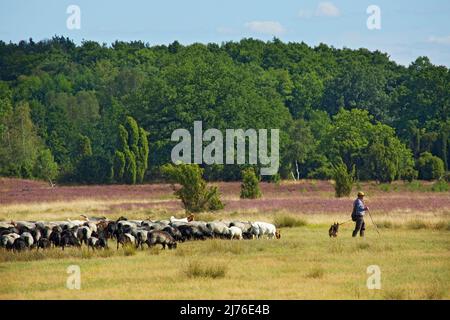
[161,163,224,212]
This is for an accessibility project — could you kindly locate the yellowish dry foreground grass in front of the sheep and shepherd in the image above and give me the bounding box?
[0,224,450,299]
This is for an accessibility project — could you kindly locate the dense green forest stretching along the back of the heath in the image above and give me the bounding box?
[0,37,450,183]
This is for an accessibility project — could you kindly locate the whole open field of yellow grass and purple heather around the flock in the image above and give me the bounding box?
[0,181,450,299]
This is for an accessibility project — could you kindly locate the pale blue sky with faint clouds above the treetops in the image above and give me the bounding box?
[0,0,450,67]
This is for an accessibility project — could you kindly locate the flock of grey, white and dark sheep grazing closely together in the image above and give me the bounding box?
[0,215,281,252]
